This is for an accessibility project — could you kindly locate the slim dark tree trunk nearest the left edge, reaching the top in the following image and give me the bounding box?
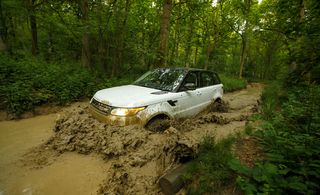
[27,0,39,56]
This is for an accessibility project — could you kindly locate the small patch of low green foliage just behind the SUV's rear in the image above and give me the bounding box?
[219,75,247,92]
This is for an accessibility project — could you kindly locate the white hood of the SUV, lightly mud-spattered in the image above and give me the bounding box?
[93,85,174,108]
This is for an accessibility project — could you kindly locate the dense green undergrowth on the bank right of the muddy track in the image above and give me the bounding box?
[186,83,320,194]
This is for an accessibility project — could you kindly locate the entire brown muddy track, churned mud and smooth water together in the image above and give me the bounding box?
[0,84,263,195]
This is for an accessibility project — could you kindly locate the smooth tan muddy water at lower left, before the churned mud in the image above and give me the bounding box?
[0,114,108,195]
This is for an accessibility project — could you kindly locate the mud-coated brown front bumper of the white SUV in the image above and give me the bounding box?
[89,105,142,126]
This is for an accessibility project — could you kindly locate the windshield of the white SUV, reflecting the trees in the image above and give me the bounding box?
[133,69,186,91]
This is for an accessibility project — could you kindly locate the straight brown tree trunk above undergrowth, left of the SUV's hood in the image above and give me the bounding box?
[79,0,91,67]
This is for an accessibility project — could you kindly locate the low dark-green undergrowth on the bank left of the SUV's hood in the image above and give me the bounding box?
[0,55,127,115]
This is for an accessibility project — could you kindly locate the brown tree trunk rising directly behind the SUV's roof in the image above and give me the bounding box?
[158,0,172,67]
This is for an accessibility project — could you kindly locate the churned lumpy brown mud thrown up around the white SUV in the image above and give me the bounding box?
[23,84,262,194]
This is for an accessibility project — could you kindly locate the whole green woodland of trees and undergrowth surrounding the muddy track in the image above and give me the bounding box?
[0,0,320,194]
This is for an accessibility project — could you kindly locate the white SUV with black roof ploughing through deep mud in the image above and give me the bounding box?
[89,68,223,130]
